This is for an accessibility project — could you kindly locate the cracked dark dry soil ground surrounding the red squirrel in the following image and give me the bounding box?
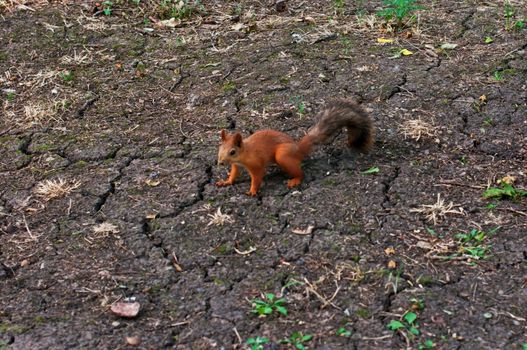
[0,0,527,349]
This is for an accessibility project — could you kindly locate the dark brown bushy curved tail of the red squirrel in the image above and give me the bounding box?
[298,100,374,157]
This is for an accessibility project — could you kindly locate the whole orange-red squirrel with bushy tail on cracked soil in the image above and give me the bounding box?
[216,99,374,196]
